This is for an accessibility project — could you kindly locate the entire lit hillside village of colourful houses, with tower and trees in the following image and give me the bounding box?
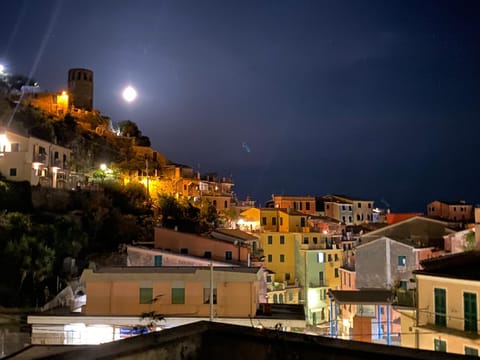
[0,69,480,356]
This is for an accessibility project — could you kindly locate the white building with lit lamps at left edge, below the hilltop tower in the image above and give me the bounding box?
[0,128,72,188]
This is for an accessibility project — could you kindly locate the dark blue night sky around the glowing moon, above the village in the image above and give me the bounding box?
[0,0,480,212]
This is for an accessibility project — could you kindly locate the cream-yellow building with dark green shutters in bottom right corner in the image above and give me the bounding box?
[401,251,480,356]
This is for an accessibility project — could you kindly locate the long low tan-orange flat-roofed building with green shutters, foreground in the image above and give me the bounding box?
[81,267,265,318]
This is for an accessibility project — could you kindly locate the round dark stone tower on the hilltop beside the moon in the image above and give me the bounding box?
[68,68,93,111]
